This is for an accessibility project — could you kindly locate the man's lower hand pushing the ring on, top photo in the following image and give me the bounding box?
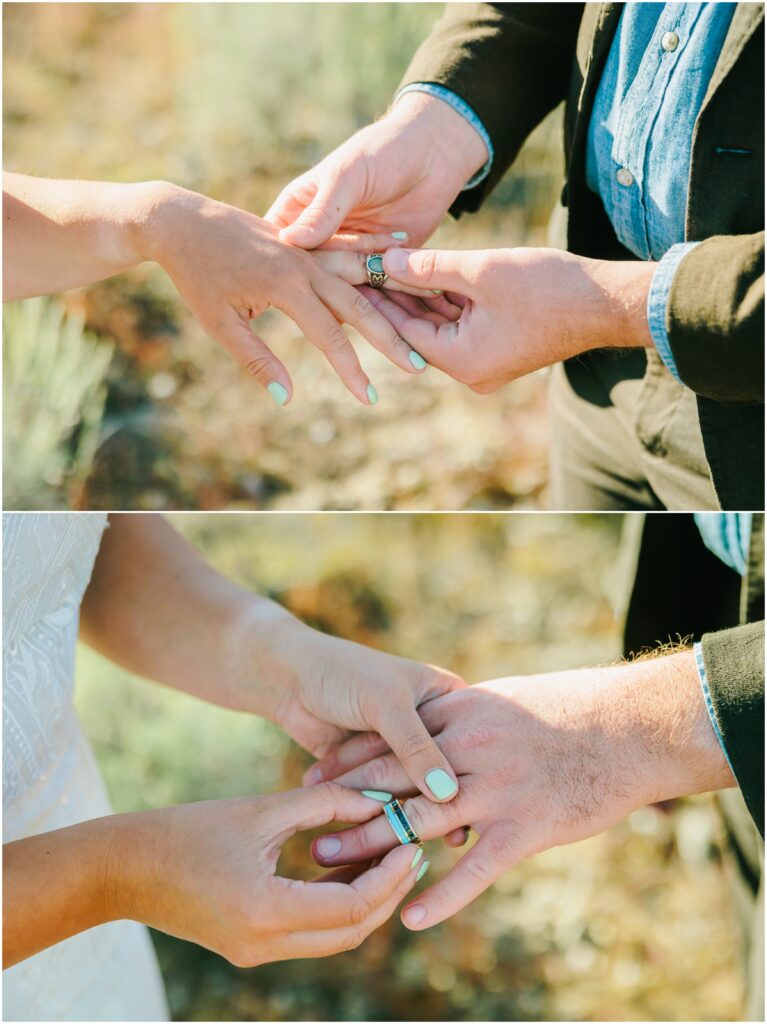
[363,249,654,394]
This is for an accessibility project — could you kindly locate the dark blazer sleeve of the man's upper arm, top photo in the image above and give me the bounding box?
[399,3,584,214]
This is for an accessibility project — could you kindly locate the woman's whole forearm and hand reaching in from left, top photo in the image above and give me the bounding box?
[3,174,440,406]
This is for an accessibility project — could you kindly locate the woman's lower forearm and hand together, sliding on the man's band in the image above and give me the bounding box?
[3,783,417,967]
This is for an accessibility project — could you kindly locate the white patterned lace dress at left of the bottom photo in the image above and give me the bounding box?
[3,512,168,1021]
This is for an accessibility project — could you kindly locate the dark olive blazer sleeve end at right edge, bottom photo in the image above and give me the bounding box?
[701,622,764,836]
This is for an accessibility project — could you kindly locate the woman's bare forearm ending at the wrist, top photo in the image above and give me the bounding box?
[3,173,172,301]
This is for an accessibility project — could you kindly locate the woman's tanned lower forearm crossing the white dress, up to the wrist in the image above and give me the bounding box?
[3,817,122,970]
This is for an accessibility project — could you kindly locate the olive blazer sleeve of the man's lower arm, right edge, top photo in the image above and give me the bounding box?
[666,231,764,402]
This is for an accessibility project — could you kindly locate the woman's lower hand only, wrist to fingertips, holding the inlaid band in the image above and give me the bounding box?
[116,783,417,967]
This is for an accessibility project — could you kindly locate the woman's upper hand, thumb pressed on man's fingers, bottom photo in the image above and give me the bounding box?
[240,602,466,802]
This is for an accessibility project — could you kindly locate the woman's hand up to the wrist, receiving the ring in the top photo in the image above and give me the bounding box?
[139,185,436,406]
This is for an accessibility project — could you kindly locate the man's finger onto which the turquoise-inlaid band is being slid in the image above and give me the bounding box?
[311,776,470,866]
